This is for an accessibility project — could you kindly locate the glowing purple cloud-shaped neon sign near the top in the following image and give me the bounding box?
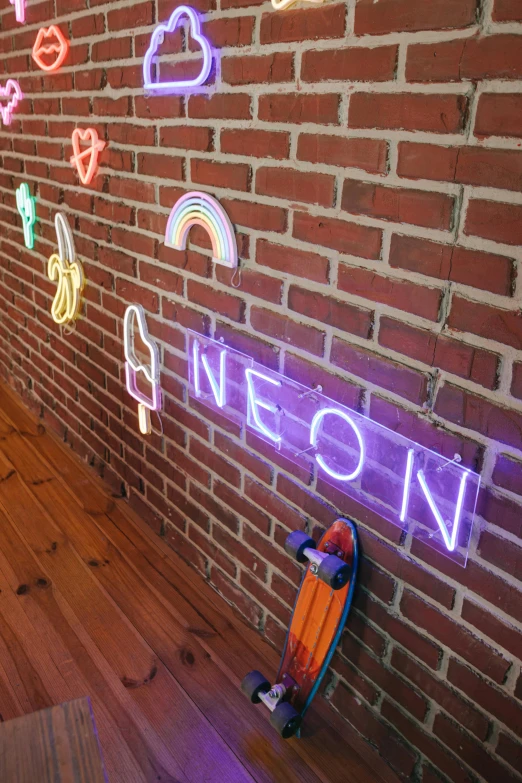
[143,5,212,92]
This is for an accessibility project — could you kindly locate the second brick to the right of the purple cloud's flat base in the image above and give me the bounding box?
[301,46,398,83]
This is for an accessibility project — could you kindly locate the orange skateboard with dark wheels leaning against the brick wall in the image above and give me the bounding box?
[241,519,359,739]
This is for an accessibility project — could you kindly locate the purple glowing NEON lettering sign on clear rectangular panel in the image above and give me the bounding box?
[188,331,480,565]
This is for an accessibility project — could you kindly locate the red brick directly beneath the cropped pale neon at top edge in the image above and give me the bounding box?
[260,3,346,44]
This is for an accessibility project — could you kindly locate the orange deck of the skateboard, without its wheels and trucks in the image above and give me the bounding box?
[276,519,359,715]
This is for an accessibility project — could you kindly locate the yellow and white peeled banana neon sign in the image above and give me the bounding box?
[47,212,85,324]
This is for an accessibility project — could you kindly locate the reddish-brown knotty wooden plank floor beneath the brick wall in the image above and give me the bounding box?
[0,385,395,783]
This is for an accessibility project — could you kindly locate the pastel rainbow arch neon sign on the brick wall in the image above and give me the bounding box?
[165,191,237,269]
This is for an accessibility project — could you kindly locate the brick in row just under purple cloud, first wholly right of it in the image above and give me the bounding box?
[258,93,339,125]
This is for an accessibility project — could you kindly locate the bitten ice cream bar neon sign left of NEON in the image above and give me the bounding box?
[123,305,161,435]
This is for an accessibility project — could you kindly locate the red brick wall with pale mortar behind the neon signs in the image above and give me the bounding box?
[0,0,522,783]
